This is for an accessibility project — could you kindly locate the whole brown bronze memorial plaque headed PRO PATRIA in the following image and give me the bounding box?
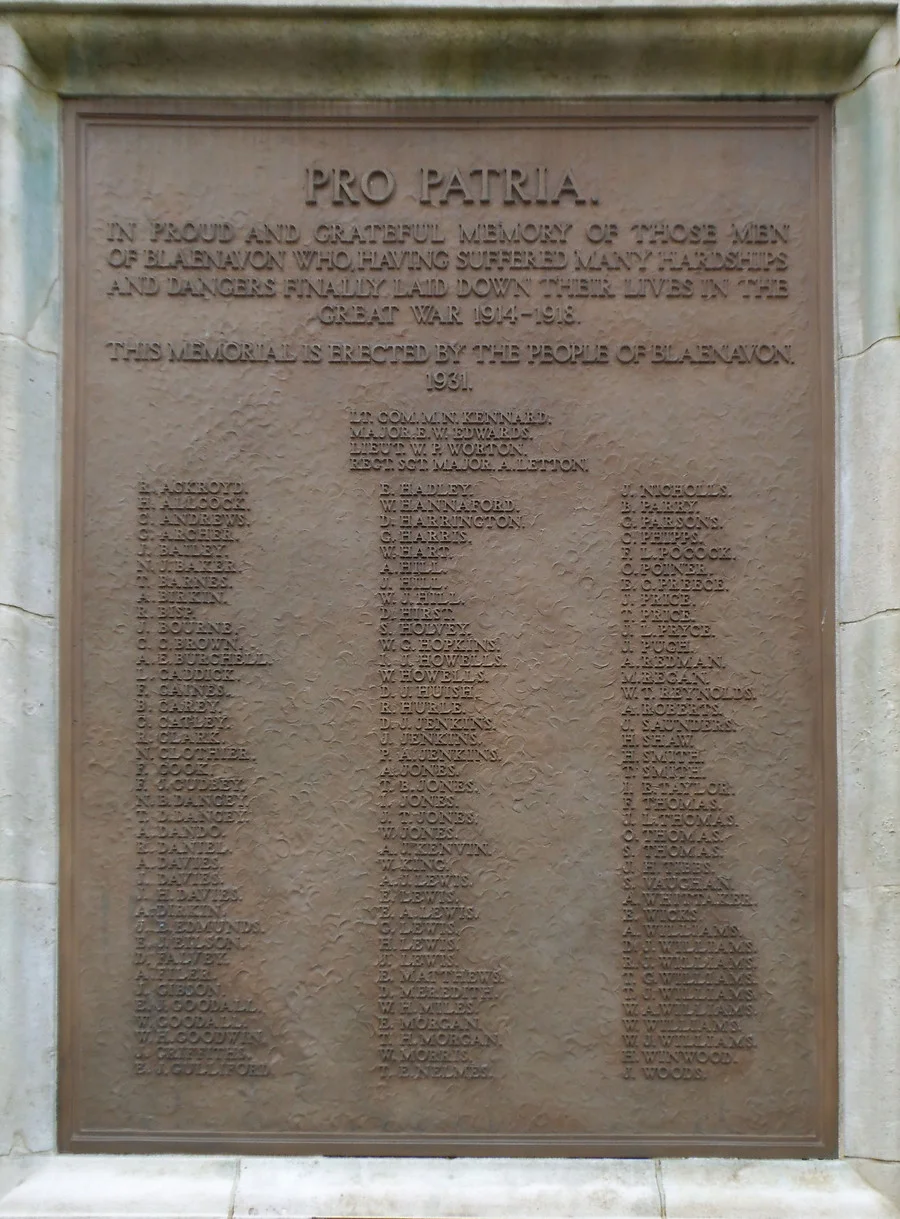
[61,101,837,1156]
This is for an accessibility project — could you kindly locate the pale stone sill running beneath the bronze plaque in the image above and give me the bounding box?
[0,1156,900,1219]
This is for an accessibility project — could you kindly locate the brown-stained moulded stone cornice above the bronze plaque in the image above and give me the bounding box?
[0,0,896,99]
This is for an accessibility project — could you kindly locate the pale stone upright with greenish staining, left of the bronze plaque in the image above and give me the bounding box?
[0,16,60,1160]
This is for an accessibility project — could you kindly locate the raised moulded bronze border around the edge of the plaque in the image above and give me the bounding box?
[57,98,839,1158]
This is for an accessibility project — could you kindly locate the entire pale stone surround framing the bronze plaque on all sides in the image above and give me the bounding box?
[0,0,900,1219]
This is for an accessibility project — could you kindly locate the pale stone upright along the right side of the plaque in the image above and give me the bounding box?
[834,52,900,1201]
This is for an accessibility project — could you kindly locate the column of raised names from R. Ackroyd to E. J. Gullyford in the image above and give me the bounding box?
[134,479,268,1075]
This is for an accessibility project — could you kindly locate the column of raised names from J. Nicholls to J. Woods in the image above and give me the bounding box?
[621,483,757,1081]
